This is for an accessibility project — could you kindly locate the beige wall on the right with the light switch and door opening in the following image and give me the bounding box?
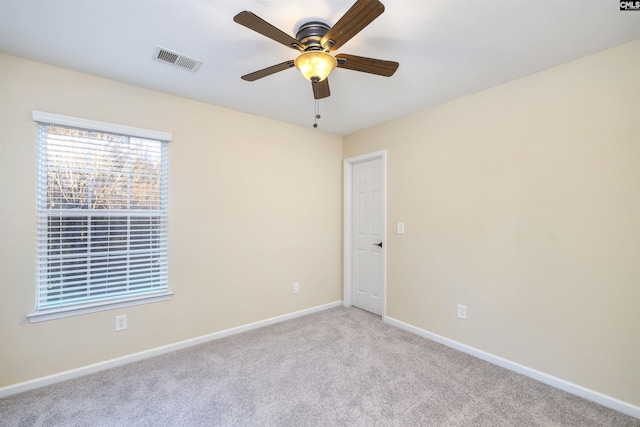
[343,40,640,406]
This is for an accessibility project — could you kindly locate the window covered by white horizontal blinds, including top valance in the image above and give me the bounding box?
[29,111,171,322]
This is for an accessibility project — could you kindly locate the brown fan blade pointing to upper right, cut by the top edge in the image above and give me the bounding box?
[320,0,384,50]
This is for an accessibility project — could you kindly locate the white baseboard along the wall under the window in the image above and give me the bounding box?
[0,301,343,398]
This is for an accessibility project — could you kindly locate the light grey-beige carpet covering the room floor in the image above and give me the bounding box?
[0,307,640,427]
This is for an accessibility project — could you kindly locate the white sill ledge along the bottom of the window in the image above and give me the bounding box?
[27,292,173,323]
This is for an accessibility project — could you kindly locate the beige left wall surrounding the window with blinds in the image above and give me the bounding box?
[0,55,342,387]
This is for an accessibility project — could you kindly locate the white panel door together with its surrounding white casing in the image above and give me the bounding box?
[344,151,386,316]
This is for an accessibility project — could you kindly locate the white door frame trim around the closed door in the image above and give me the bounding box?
[342,150,387,319]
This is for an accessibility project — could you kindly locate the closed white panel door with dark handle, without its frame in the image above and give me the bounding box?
[351,158,385,315]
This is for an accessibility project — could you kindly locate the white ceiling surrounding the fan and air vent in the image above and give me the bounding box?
[0,0,640,135]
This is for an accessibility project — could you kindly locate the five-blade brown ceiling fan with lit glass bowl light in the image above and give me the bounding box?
[233,0,400,100]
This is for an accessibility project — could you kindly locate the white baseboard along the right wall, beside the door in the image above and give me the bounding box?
[383,316,640,419]
